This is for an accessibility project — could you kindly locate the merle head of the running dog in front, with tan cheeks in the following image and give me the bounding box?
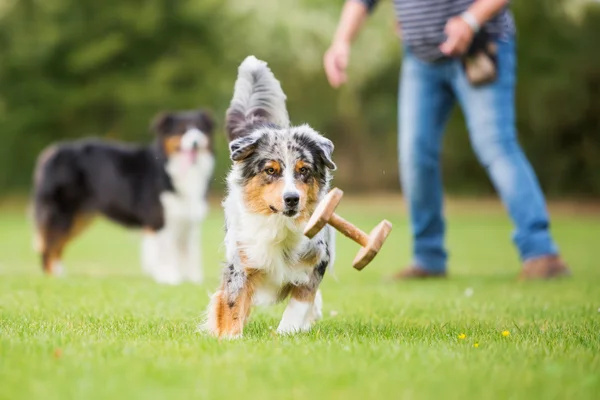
[229,125,336,218]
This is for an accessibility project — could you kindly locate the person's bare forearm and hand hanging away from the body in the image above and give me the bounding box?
[323,0,377,88]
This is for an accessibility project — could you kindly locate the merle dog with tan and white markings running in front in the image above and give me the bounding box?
[201,56,335,338]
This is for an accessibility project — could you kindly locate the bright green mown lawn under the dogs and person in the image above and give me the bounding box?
[0,199,600,400]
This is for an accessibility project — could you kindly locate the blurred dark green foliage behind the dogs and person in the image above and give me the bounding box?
[0,0,600,198]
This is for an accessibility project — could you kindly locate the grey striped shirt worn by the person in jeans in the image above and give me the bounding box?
[350,0,515,61]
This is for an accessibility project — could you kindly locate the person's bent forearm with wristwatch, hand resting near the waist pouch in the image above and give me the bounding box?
[440,0,510,56]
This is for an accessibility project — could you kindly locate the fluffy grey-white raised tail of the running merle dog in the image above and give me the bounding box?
[225,56,290,141]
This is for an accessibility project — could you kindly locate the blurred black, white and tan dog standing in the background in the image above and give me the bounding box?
[33,110,214,284]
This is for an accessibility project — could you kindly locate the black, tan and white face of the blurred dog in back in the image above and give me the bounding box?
[151,110,214,165]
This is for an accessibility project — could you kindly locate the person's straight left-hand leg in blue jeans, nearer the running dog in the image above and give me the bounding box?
[398,50,454,277]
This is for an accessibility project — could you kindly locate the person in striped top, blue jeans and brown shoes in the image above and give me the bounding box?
[323,0,570,279]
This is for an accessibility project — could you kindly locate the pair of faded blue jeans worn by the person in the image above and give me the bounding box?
[399,38,558,272]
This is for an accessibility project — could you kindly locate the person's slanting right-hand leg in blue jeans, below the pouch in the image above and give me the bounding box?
[452,39,558,276]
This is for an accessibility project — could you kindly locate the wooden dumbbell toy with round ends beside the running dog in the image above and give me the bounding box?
[304,188,392,271]
